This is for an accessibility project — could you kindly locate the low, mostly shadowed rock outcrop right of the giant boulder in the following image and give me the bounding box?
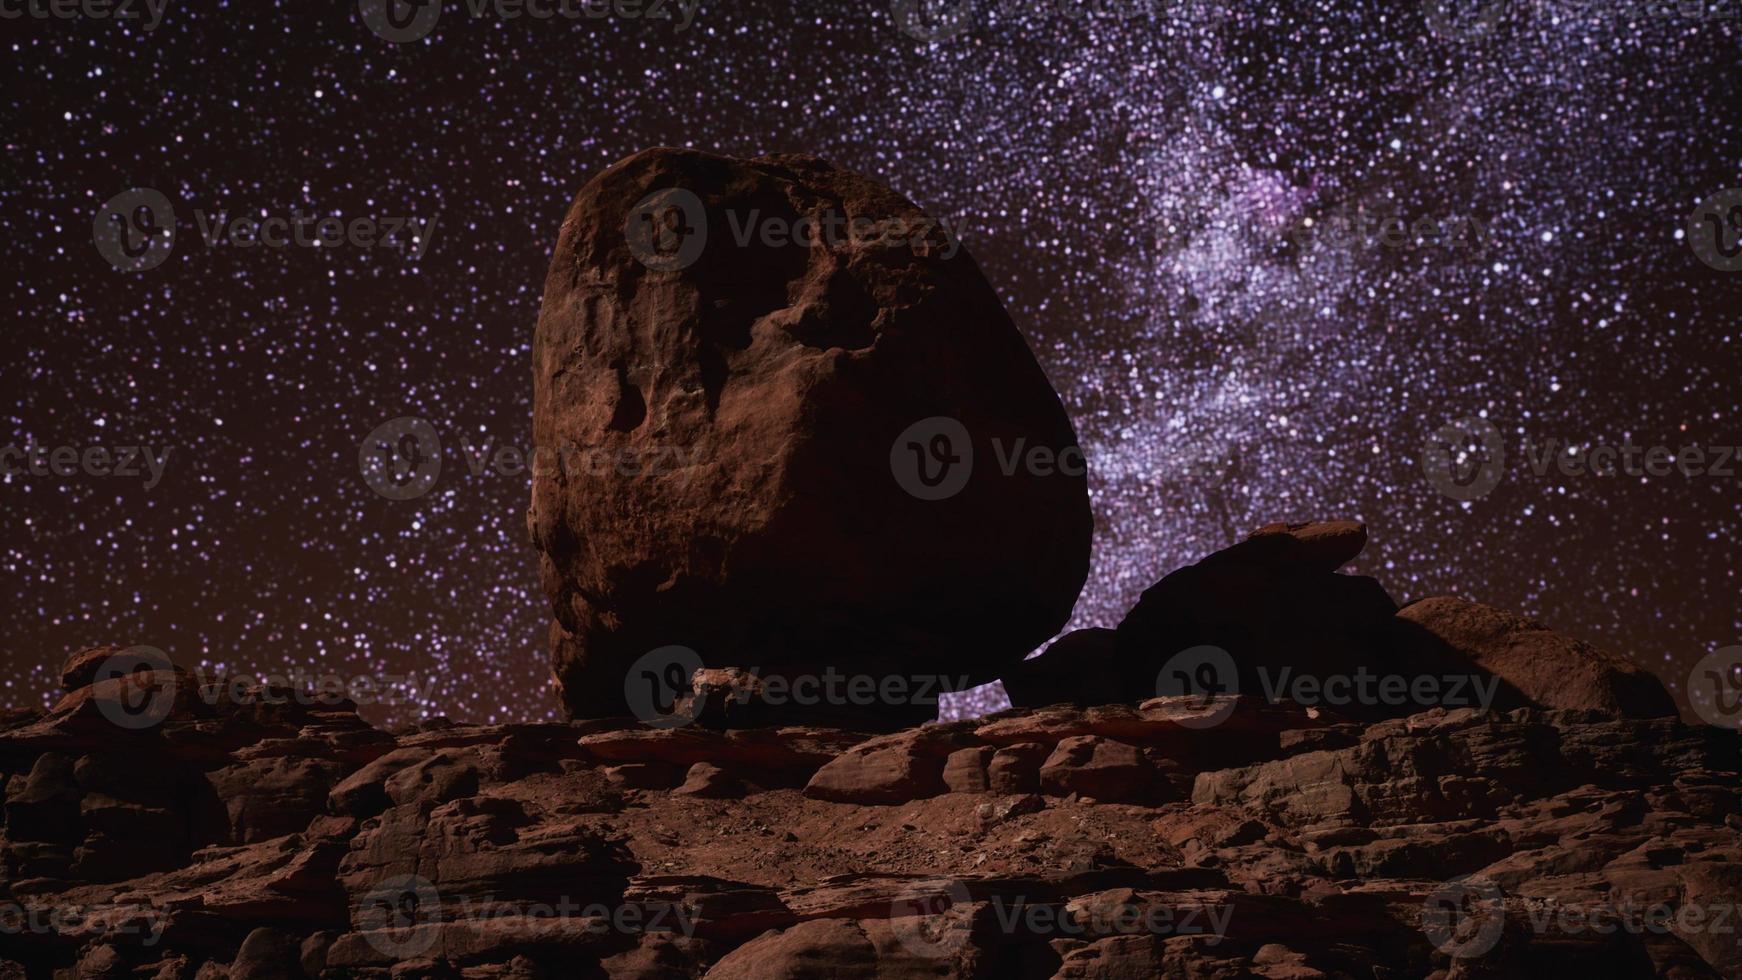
[1003,520,1676,727]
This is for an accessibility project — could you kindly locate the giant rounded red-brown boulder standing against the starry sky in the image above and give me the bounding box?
[526,150,1090,717]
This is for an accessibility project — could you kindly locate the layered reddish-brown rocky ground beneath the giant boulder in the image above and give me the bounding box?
[0,526,1742,978]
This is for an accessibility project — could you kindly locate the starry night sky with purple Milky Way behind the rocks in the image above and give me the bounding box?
[0,0,1742,722]
